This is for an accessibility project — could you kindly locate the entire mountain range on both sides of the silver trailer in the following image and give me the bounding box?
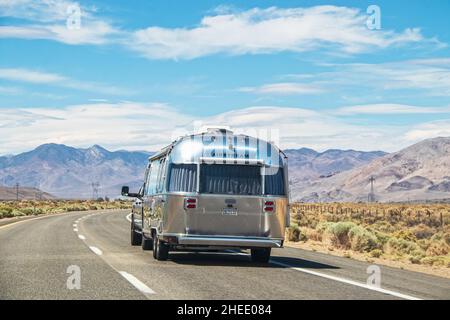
[0,138,450,202]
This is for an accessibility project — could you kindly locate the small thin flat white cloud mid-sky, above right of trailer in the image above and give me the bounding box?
[239,82,323,95]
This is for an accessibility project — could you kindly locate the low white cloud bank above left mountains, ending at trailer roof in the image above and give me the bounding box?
[0,102,192,154]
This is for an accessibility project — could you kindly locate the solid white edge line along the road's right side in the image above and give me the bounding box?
[229,251,422,300]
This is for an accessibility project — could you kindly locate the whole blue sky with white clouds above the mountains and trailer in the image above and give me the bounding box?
[0,0,450,154]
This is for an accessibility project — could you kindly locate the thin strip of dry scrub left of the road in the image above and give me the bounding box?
[0,200,132,219]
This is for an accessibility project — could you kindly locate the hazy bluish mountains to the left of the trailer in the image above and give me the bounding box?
[0,144,151,198]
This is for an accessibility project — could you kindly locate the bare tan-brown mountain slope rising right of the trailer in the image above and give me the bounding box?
[292,138,450,202]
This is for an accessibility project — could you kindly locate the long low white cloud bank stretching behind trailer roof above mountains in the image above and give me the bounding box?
[0,102,424,154]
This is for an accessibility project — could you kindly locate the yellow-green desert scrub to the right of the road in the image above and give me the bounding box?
[287,203,450,268]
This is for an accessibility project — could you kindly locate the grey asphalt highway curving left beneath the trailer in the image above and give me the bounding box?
[0,211,450,300]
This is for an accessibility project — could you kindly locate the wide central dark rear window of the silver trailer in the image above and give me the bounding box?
[200,164,262,195]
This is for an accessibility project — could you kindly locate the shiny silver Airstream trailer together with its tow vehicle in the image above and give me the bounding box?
[122,129,289,262]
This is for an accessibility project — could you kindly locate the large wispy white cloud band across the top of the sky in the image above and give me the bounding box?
[0,0,442,59]
